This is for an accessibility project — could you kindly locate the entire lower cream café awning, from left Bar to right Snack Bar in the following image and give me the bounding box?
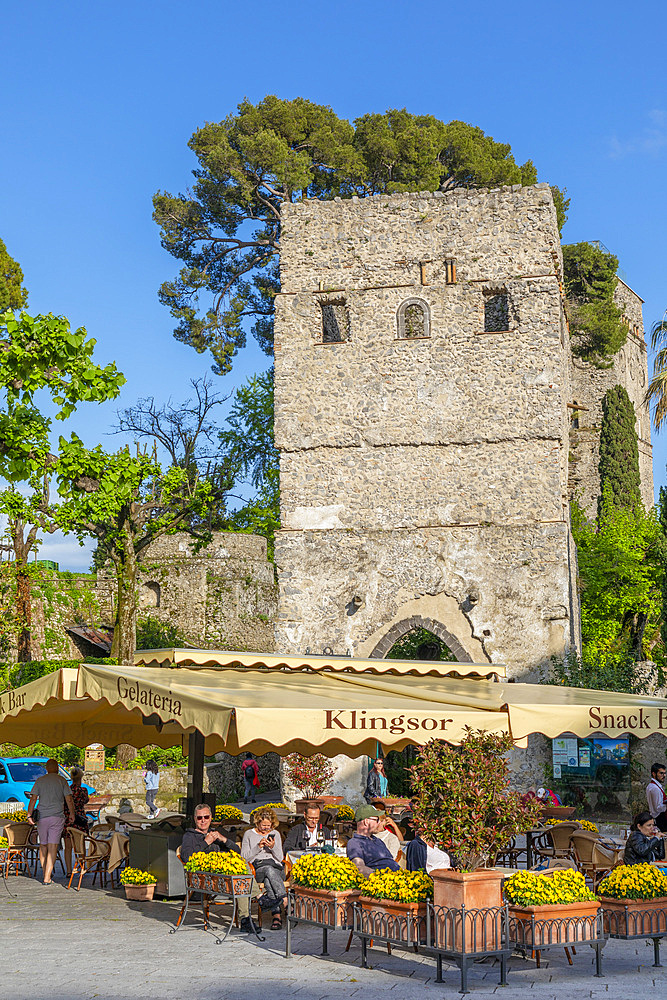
[0,654,667,756]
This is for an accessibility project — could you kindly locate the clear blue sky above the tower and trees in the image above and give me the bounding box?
[0,0,667,569]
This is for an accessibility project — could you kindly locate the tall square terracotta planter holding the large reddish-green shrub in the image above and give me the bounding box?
[430,868,507,954]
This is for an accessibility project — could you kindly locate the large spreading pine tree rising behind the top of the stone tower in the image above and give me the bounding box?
[153,96,552,373]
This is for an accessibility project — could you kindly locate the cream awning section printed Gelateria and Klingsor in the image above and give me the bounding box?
[78,665,508,756]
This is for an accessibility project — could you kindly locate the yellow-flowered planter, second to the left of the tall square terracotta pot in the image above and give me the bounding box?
[290,854,364,928]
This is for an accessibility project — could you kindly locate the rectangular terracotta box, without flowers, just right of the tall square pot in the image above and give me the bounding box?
[509,899,600,951]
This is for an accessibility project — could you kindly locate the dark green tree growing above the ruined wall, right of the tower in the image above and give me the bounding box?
[563,243,627,368]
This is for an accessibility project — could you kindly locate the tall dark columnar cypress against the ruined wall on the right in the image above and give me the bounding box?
[598,385,642,511]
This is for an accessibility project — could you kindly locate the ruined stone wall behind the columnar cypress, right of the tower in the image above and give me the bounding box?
[569,279,654,516]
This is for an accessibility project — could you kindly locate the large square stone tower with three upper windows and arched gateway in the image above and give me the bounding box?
[275,184,648,678]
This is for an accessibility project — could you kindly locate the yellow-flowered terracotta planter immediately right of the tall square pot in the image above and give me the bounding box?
[503,868,600,951]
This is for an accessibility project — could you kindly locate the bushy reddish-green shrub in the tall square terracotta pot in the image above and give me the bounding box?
[411,728,541,909]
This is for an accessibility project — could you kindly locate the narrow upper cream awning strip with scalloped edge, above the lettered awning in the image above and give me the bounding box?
[134,649,506,677]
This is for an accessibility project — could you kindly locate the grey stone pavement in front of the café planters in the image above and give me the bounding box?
[0,877,667,1000]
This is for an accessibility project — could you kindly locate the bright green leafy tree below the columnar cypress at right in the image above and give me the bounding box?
[571,487,665,670]
